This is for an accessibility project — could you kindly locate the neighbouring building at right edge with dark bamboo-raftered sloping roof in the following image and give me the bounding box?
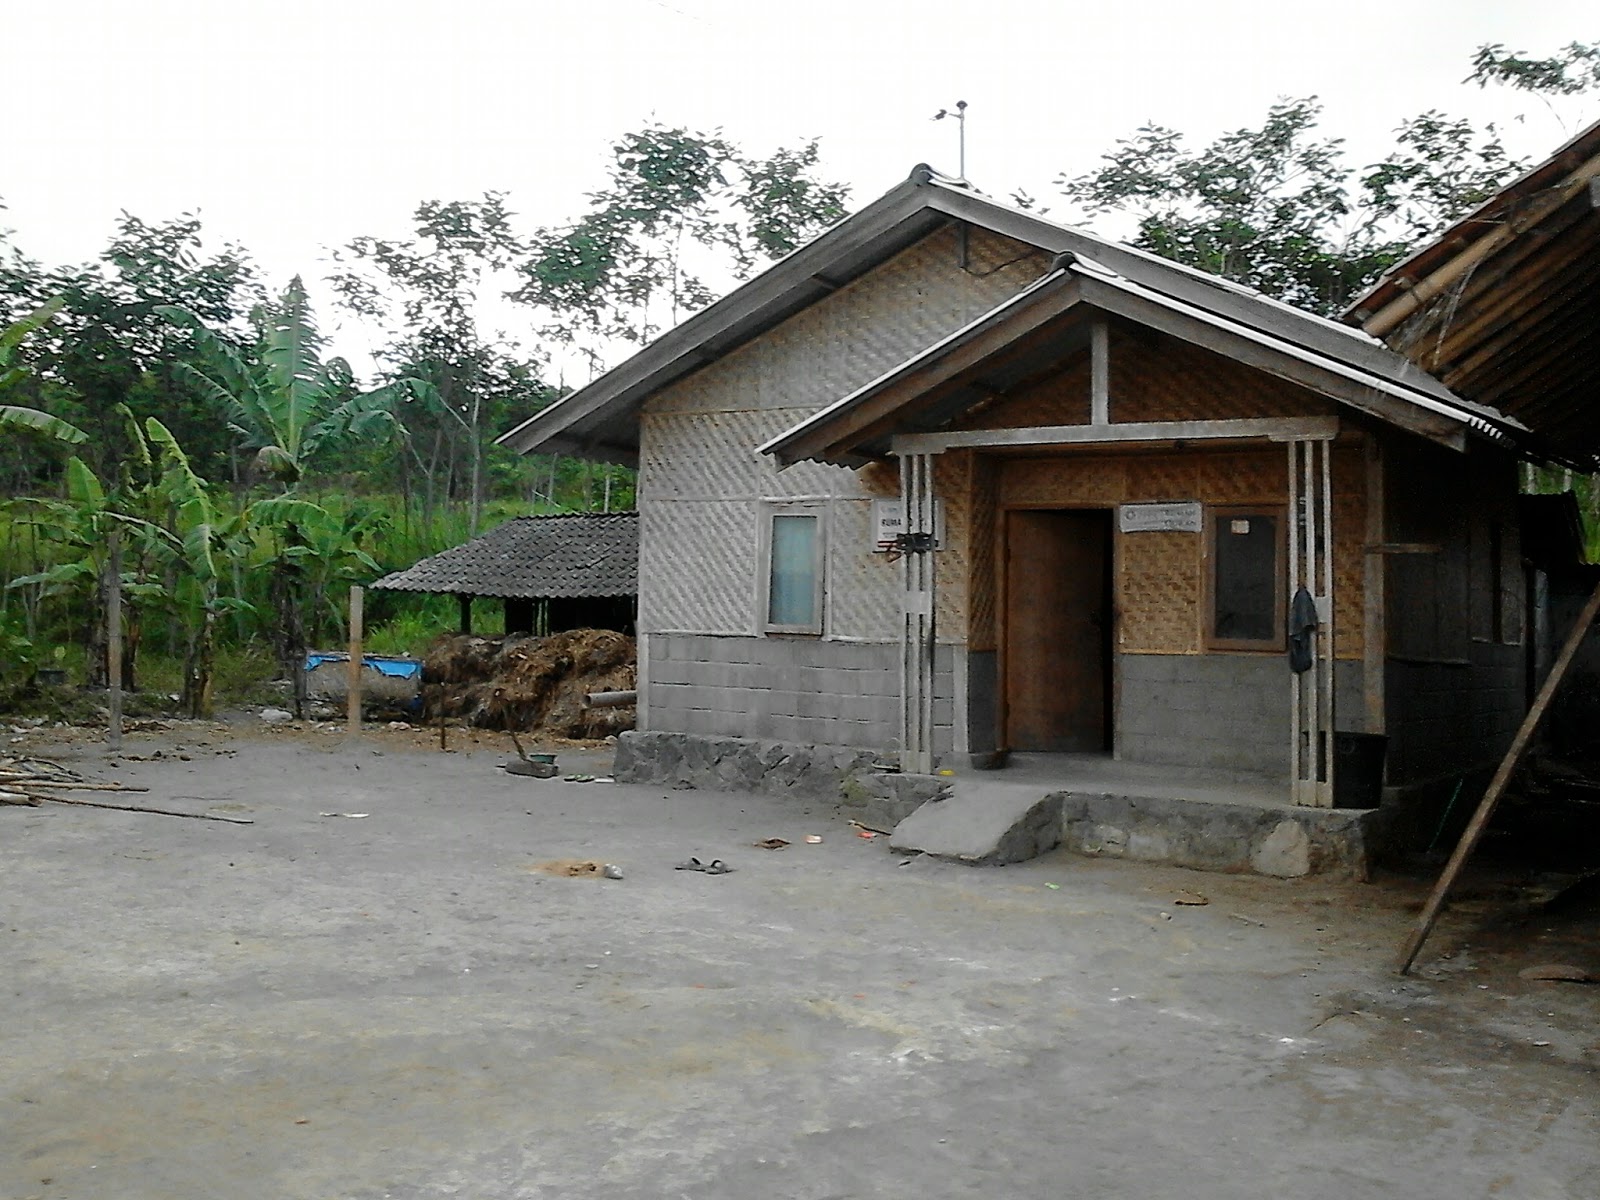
[1346,123,1600,754]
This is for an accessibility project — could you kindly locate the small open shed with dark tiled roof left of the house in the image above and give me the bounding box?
[373,512,638,634]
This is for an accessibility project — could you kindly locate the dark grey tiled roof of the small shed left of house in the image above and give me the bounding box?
[373,512,638,600]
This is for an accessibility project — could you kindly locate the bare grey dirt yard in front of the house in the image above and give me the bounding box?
[0,725,1600,1200]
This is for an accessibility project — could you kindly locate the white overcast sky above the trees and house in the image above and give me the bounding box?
[0,0,1600,366]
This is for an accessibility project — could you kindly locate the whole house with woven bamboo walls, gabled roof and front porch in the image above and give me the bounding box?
[502,168,1525,805]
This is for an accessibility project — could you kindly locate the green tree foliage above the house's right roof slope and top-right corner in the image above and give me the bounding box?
[1056,43,1600,314]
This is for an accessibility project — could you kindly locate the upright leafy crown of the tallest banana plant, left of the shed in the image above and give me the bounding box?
[157,275,413,491]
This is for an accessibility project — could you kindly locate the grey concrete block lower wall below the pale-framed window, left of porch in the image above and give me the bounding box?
[643,634,955,754]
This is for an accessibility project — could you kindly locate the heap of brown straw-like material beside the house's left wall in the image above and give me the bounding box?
[422,629,638,738]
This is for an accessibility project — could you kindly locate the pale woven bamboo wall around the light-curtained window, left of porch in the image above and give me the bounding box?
[638,229,1048,640]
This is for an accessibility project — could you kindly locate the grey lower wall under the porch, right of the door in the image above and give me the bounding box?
[1115,654,1363,779]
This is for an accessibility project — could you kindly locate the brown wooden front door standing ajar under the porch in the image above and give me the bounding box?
[1003,509,1112,754]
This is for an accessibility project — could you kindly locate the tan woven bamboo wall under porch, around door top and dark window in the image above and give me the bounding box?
[992,446,1365,658]
